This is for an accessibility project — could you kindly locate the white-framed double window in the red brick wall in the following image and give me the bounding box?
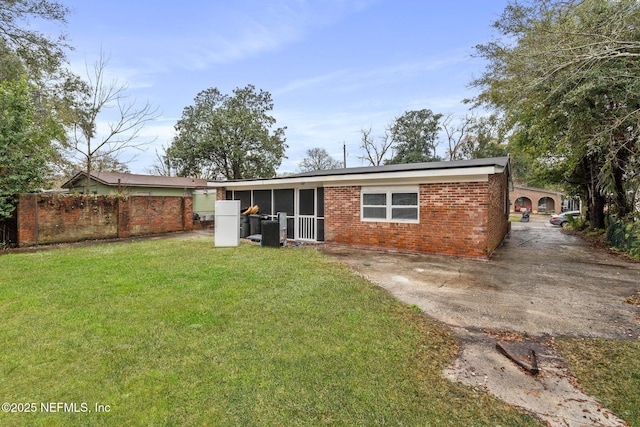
[361,187,419,223]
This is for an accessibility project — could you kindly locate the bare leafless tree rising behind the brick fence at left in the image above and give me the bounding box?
[68,53,159,193]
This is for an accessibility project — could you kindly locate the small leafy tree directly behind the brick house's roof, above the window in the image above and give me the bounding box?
[387,108,443,164]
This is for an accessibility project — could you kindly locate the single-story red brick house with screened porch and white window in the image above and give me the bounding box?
[209,157,510,258]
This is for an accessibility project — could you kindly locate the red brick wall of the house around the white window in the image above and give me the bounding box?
[324,175,507,258]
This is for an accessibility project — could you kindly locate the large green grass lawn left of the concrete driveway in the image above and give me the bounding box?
[0,239,544,426]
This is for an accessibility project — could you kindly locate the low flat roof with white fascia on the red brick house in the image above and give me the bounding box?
[209,157,510,188]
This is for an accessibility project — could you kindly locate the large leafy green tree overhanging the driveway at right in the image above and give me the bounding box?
[473,0,640,228]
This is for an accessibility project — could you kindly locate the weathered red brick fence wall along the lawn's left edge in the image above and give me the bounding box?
[17,194,193,247]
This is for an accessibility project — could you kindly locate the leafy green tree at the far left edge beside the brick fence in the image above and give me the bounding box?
[0,77,62,220]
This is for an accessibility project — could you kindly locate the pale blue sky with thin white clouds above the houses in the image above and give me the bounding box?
[61,0,507,173]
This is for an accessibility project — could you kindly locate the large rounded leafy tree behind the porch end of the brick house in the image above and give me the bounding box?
[167,85,287,179]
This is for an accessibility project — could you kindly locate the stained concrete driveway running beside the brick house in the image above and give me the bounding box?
[324,216,640,426]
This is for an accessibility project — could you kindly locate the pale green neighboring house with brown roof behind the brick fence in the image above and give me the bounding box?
[62,172,215,219]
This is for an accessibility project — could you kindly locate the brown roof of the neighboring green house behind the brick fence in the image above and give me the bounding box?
[62,171,207,188]
